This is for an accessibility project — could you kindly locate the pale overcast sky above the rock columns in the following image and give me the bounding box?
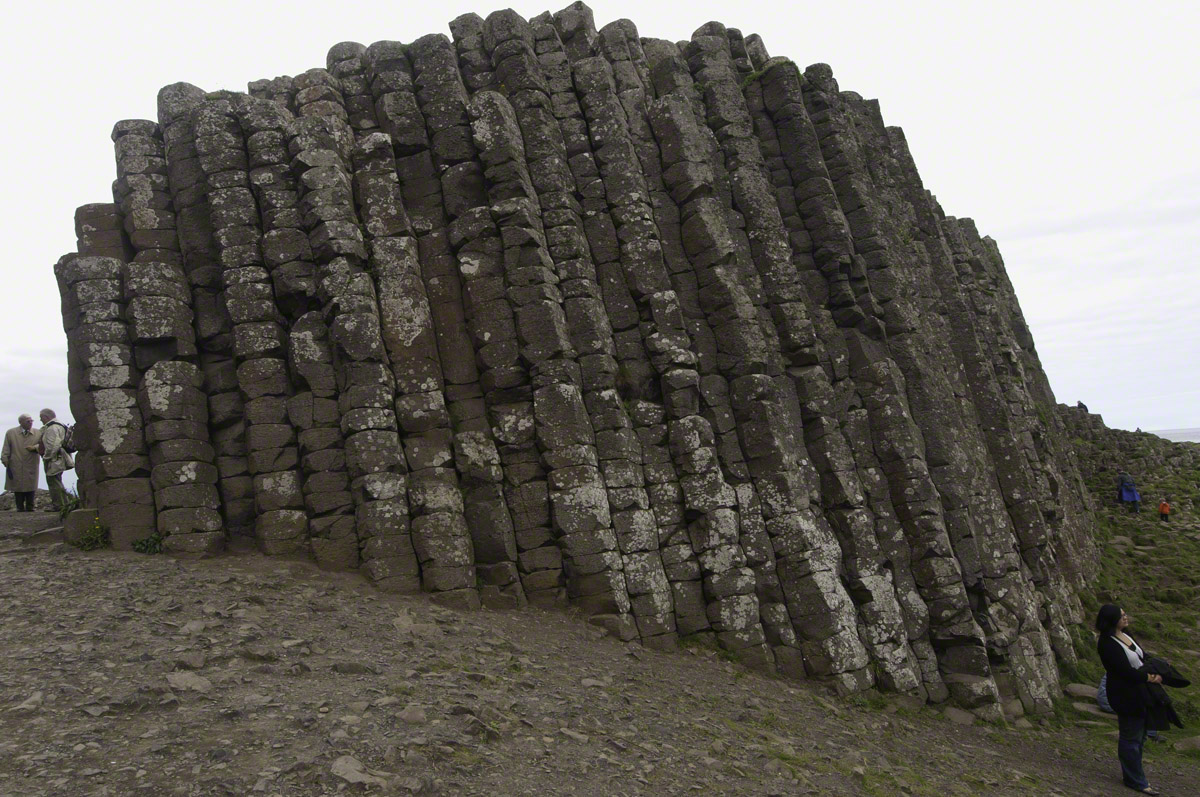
[0,0,1200,470]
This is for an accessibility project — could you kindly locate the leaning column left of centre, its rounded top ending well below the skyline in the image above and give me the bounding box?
[468,85,634,635]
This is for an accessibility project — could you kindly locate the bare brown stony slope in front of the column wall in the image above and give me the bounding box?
[0,513,1200,797]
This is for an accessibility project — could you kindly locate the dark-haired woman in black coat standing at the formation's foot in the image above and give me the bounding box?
[1096,604,1163,795]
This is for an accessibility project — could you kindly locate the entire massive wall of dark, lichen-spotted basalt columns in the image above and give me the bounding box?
[56,4,1094,717]
